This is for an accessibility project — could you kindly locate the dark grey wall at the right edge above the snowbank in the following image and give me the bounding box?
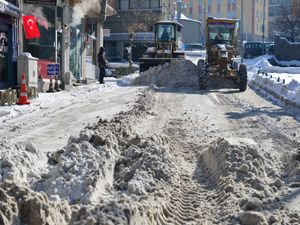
[274,34,300,61]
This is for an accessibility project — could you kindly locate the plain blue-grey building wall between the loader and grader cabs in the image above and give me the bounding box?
[179,19,201,43]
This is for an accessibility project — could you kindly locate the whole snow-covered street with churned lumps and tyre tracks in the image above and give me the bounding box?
[0,58,300,225]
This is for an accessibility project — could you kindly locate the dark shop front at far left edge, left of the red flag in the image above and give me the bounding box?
[0,0,20,88]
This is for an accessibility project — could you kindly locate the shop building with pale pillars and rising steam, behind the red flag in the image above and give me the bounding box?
[22,0,114,84]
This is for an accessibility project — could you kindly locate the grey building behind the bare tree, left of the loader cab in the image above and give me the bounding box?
[104,0,175,61]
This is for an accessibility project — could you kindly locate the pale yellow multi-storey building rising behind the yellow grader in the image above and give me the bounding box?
[183,0,269,41]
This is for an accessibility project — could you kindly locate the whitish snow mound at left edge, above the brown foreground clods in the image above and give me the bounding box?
[0,141,47,183]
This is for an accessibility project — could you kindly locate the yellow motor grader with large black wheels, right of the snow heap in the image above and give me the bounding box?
[197,17,247,91]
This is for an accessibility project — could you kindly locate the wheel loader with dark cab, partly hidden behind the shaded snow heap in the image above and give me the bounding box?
[140,21,185,72]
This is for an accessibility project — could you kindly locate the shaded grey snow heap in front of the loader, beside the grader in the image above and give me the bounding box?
[134,59,199,87]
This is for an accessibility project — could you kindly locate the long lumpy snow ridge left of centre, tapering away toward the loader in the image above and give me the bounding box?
[36,91,158,204]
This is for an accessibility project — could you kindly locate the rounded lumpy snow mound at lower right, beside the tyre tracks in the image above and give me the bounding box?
[200,138,300,225]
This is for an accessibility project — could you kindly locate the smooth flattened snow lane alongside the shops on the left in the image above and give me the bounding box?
[0,79,137,152]
